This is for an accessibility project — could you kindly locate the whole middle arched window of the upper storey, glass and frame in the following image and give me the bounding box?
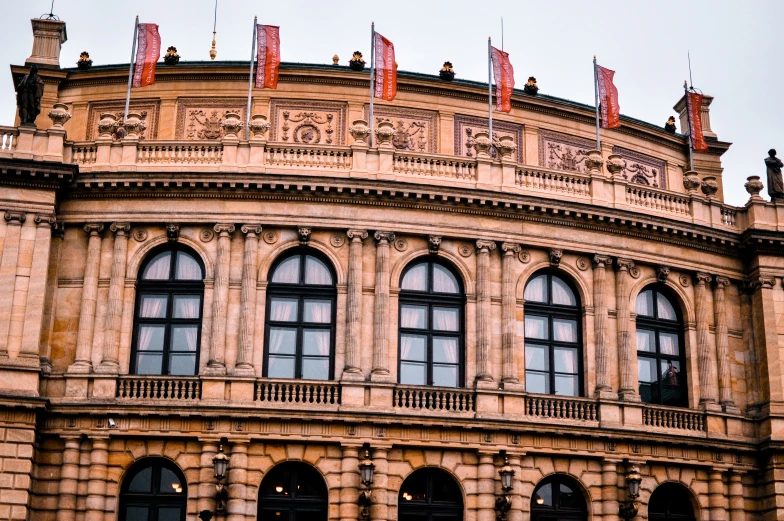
[398,259,465,387]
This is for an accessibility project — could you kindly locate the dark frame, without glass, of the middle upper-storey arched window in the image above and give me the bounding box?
[397,257,467,389]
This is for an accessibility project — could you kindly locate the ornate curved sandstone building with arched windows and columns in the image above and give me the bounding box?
[0,15,784,521]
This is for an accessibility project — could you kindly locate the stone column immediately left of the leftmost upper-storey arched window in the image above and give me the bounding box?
[96,223,131,373]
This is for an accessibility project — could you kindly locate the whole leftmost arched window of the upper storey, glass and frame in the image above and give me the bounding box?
[131,243,204,375]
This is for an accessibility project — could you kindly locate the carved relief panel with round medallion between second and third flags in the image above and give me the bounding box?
[270,100,347,145]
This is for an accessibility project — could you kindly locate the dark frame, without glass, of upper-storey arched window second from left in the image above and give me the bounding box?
[262,248,338,381]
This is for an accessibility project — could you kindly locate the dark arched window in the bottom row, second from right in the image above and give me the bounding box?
[531,474,588,521]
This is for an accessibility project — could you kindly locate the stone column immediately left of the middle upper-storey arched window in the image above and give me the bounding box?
[370,231,395,380]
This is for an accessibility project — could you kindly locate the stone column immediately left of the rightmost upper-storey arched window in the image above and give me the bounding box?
[615,258,640,401]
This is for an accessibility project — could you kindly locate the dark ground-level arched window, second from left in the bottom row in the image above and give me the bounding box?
[258,462,328,521]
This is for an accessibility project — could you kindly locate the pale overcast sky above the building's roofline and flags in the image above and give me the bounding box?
[0,0,784,205]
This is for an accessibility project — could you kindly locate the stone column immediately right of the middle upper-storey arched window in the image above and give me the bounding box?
[476,239,495,382]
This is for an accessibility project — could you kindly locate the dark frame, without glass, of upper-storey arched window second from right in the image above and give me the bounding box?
[523,270,585,397]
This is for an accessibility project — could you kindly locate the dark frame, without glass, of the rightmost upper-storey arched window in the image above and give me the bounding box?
[634,284,689,407]
